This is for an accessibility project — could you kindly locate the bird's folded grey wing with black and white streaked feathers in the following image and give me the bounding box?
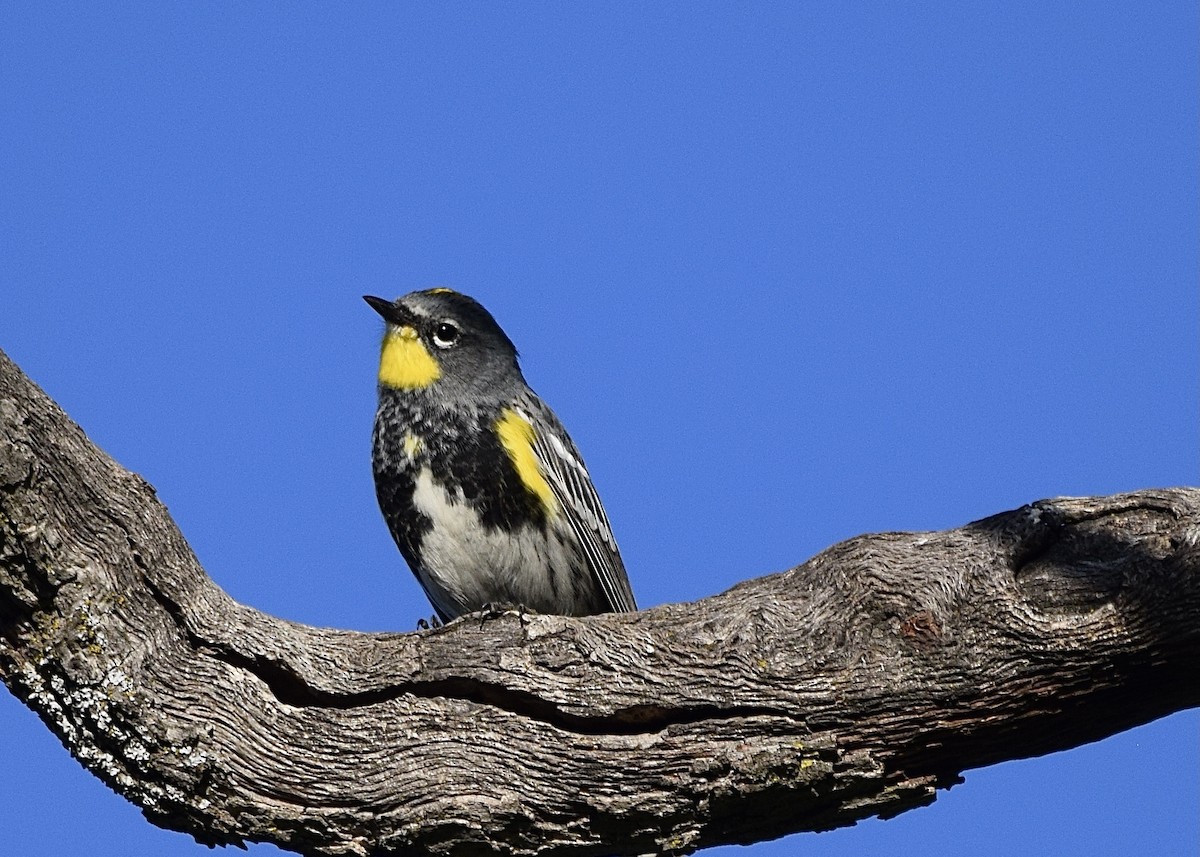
[522,400,637,612]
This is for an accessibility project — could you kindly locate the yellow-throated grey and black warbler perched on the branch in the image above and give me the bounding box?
[364,288,637,622]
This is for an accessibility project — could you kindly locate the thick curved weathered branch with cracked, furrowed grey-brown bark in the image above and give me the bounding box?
[0,343,1200,855]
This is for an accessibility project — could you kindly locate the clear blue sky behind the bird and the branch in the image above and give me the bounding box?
[0,1,1200,857]
